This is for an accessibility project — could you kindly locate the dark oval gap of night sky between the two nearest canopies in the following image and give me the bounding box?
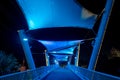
[26,27,96,41]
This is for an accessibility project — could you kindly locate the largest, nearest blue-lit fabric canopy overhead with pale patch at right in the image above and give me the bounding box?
[17,0,97,30]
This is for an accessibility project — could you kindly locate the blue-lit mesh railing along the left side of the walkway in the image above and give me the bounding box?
[0,65,58,80]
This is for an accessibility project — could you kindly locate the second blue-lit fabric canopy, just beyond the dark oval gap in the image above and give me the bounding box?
[38,40,82,54]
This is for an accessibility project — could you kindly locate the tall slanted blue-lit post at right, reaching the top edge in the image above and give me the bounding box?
[88,0,114,70]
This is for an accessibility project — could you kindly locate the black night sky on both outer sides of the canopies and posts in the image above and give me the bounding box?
[0,0,120,76]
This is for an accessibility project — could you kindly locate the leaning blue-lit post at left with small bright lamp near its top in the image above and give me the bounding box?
[18,30,35,69]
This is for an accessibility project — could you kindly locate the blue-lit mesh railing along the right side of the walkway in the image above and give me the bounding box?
[67,65,120,80]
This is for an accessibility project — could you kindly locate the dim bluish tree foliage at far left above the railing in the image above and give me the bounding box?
[0,51,20,75]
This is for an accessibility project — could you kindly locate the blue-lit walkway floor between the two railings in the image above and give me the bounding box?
[42,68,82,80]
